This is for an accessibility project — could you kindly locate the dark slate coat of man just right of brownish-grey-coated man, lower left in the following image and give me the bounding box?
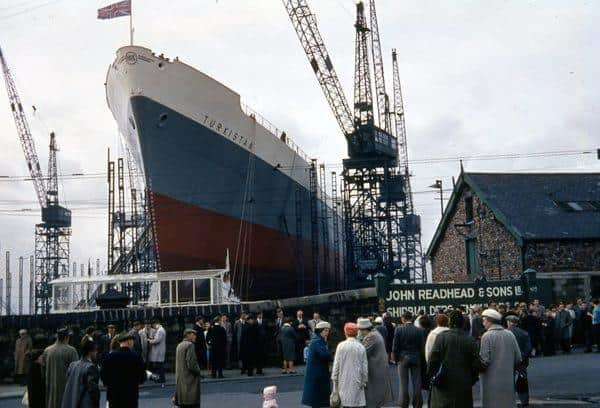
[61,359,100,408]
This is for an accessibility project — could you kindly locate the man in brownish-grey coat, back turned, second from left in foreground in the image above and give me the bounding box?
[42,328,79,408]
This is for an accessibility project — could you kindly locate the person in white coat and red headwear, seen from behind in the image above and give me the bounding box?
[331,323,369,408]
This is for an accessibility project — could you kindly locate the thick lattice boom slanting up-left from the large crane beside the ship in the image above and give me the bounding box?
[282,0,354,137]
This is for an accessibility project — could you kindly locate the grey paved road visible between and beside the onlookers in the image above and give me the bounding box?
[0,353,600,408]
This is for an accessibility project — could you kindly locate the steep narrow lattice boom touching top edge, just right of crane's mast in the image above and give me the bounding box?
[369,0,392,132]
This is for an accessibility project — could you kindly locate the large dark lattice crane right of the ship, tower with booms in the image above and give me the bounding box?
[282,0,424,287]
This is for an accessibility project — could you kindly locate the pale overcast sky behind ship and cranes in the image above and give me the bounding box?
[0,0,600,302]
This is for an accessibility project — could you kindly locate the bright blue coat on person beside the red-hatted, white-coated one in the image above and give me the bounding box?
[302,334,332,408]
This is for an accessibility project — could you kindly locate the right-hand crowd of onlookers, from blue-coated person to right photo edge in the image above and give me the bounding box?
[302,299,600,408]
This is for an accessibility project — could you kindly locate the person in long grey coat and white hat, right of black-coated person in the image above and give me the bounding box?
[479,309,521,408]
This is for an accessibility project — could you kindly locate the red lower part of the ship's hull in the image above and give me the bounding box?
[151,193,328,300]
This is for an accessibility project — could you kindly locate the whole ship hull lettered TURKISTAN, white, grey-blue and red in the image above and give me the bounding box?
[106,46,344,300]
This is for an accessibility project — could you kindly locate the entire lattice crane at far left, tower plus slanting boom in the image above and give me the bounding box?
[0,49,71,313]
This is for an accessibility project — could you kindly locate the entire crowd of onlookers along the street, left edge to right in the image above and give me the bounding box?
[8,300,600,408]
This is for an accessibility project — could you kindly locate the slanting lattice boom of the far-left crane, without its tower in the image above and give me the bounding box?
[0,49,47,208]
